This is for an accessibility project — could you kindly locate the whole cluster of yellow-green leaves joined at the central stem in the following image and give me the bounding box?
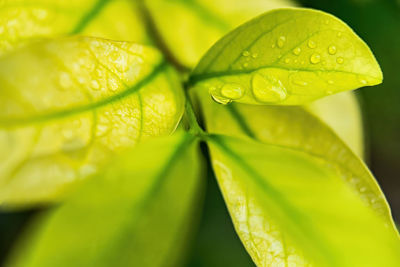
[0,0,400,267]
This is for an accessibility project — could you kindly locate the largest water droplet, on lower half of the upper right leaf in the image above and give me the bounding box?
[252,74,287,103]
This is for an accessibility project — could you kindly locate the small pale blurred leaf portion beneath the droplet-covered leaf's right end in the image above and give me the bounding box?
[306,91,364,159]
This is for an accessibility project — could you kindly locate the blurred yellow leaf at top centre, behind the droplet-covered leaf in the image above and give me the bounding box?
[144,0,293,67]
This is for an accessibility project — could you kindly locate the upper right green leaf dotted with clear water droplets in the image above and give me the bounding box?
[190,9,382,105]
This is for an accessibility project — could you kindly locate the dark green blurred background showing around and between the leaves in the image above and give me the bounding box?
[0,0,400,267]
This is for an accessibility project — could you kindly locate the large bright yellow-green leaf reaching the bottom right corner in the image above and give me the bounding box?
[208,135,400,267]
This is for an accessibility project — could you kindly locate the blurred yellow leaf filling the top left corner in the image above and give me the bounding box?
[0,0,151,55]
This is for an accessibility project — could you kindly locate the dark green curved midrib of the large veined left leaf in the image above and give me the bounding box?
[0,59,168,128]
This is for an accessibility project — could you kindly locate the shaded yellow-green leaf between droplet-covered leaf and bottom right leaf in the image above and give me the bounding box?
[199,92,393,224]
